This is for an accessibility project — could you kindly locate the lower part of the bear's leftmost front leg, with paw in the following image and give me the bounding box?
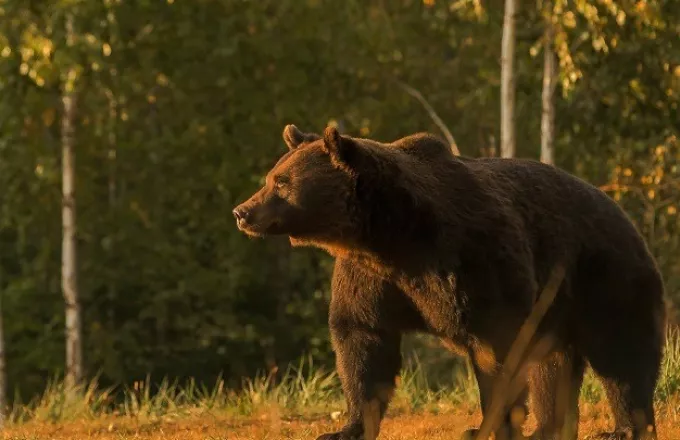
[317,321,401,440]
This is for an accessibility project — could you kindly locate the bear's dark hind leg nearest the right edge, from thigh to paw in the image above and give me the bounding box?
[574,258,666,440]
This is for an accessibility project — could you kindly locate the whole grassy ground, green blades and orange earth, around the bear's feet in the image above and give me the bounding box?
[2,329,680,440]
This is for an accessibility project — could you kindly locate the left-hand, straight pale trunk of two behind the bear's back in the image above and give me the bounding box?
[501,0,517,157]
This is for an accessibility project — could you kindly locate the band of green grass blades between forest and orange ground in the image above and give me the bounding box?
[7,329,680,424]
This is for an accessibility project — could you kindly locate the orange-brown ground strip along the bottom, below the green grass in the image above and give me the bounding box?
[2,405,680,440]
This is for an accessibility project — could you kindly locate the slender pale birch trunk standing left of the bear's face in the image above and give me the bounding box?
[61,75,83,388]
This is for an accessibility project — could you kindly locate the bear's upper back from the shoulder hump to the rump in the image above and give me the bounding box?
[362,133,647,258]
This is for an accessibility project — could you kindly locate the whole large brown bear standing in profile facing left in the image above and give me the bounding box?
[233,125,666,440]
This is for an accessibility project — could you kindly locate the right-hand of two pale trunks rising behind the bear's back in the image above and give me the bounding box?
[541,9,557,165]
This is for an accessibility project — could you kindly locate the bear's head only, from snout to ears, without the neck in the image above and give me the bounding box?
[233,125,362,251]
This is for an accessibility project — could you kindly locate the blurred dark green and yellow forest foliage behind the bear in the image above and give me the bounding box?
[0,0,680,404]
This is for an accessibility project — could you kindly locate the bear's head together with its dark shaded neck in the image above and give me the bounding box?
[233,125,434,254]
